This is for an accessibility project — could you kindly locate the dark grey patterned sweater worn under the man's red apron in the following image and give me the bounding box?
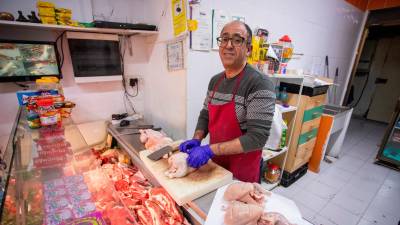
[196,65,275,152]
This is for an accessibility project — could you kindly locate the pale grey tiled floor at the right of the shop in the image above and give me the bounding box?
[273,118,400,225]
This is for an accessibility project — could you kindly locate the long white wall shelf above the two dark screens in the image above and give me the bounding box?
[0,20,158,36]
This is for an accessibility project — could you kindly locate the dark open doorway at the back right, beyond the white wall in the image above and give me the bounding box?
[344,8,400,123]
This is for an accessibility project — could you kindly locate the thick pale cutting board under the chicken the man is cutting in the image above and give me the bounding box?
[140,150,232,205]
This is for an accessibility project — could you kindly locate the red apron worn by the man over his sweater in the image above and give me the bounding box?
[208,70,261,182]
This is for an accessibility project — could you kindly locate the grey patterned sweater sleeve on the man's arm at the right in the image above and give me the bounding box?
[239,78,275,152]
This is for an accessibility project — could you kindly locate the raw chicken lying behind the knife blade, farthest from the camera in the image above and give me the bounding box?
[139,129,173,150]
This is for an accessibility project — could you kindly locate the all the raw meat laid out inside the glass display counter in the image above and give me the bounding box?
[2,123,189,225]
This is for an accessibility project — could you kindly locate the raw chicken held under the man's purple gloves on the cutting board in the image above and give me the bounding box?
[165,152,196,178]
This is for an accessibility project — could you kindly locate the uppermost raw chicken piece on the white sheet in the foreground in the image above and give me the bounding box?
[224,182,270,206]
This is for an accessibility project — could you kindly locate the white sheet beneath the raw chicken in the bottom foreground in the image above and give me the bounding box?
[204,185,311,225]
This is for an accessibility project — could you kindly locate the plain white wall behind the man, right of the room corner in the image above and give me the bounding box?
[187,0,364,137]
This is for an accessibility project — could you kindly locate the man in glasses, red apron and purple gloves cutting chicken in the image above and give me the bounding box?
[179,21,275,182]
